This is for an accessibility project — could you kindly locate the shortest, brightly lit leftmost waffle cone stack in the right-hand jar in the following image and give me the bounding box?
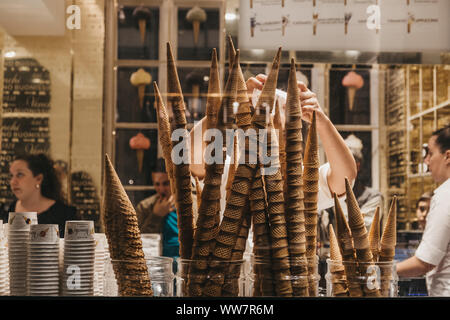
[328,224,348,297]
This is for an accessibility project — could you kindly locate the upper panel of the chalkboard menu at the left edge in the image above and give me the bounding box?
[3,58,50,113]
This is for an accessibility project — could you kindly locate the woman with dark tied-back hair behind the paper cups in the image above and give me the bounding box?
[3,154,77,237]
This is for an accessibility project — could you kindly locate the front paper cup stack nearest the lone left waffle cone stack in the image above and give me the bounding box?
[61,220,95,296]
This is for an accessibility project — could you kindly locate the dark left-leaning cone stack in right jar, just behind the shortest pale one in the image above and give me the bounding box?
[334,194,363,297]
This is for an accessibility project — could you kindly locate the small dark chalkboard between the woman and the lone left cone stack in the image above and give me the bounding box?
[70,171,100,232]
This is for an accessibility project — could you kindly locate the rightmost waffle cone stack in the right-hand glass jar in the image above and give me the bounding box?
[379,196,397,297]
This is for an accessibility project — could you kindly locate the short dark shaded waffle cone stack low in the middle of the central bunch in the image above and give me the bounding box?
[250,170,275,297]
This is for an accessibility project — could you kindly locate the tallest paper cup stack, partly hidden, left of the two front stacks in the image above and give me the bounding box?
[8,212,37,296]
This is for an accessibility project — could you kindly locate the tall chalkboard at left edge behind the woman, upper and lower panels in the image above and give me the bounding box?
[0,58,50,203]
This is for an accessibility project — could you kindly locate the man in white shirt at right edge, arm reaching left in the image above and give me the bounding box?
[397,125,450,296]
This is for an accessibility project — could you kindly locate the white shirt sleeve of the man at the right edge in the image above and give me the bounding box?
[415,189,450,266]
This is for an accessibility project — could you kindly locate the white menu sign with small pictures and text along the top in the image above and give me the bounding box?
[239,0,450,52]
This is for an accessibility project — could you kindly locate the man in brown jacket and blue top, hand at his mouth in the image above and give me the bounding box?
[136,158,180,258]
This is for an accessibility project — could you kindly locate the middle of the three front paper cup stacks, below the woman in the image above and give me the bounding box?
[27,224,59,296]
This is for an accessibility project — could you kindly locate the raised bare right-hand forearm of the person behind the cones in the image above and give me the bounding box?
[317,112,357,194]
